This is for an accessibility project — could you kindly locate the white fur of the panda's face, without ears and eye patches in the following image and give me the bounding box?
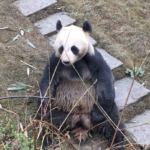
[54,25,94,64]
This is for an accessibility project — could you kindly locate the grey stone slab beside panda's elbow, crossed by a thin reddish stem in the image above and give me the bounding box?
[115,77,150,110]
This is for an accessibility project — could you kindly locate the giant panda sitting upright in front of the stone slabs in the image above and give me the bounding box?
[37,20,124,150]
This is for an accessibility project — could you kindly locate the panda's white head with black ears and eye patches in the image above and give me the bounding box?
[54,20,94,65]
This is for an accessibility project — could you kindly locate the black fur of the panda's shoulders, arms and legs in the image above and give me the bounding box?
[37,49,123,150]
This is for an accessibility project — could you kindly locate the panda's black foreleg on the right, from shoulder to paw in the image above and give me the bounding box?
[84,49,115,121]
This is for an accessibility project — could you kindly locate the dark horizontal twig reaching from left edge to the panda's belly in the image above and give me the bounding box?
[0,95,55,100]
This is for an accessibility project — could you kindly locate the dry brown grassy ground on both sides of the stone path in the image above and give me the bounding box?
[0,0,150,149]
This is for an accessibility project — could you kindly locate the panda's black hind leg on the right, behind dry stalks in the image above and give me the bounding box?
[93,103,124,150]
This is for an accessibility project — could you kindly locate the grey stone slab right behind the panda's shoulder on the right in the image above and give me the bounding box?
[96,47,123,69]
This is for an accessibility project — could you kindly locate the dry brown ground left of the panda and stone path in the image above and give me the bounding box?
[0,0,53,122]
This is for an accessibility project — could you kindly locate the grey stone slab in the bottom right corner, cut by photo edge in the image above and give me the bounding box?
[125,110,150,145]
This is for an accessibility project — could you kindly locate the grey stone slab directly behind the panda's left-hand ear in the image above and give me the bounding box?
[34,13,76,35]
